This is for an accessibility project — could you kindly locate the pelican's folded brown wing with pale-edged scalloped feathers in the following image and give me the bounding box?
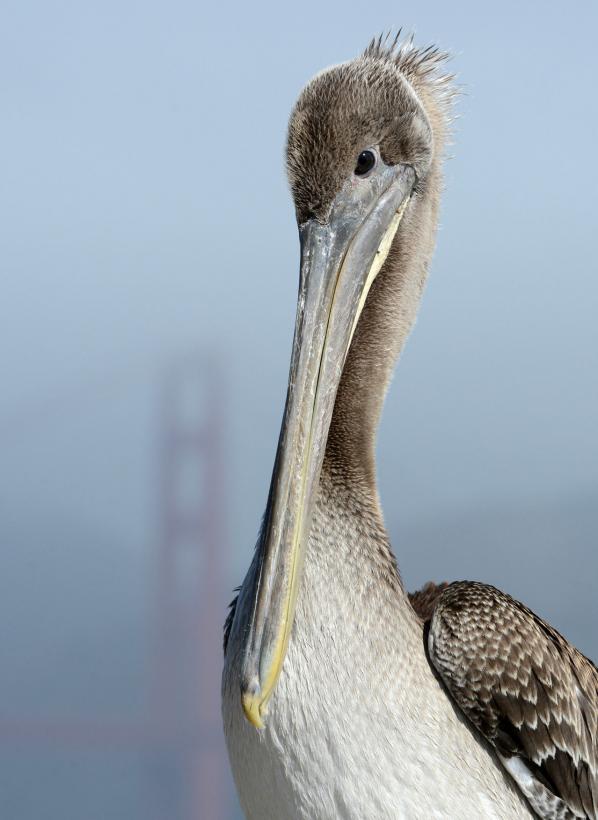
[428,581,598,820]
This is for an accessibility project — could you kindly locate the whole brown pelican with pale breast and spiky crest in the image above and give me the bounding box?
[223,39,598,820]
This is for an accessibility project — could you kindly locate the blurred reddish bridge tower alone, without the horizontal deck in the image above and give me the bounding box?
[153,356,232,820]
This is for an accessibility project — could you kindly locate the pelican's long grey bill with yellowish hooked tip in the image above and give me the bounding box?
[241,165,414,728]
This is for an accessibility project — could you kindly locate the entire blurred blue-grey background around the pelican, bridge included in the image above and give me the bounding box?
[0,0,598,820]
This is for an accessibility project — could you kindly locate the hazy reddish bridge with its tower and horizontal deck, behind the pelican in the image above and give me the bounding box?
[0,355,233,820]
